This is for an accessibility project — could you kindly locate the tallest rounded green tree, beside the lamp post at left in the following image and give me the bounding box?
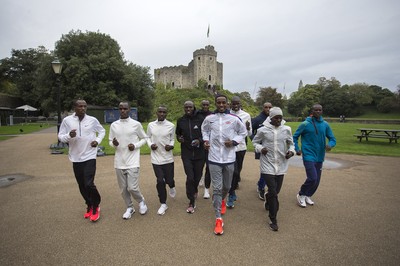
[55,31,125,110]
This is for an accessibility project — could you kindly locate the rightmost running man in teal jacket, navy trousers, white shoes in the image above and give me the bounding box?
[293,104,336,208]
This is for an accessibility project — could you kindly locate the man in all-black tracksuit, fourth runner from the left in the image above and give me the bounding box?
[175,101,205,213]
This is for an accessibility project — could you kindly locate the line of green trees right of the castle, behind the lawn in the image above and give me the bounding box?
[256,77,400,117]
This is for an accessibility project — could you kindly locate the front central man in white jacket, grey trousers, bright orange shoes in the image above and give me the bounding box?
[201,95,247,235]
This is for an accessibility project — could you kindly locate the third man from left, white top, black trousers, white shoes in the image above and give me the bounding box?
[147,106,176,215]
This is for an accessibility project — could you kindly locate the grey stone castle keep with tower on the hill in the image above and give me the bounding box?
[154,45,223,88]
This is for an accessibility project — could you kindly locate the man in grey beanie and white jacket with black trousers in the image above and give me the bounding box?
[253,107,295,231]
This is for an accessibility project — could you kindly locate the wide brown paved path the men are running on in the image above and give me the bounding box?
[0,129,400,265]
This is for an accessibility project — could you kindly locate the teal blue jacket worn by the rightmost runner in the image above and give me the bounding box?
[293,116,336,162]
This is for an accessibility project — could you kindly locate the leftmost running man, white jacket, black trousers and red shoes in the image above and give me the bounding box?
[58,100,106,222]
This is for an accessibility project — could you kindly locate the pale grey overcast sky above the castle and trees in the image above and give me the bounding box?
[0,0,400,97]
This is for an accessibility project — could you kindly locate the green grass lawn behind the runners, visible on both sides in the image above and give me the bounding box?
[0,122,400,157]
